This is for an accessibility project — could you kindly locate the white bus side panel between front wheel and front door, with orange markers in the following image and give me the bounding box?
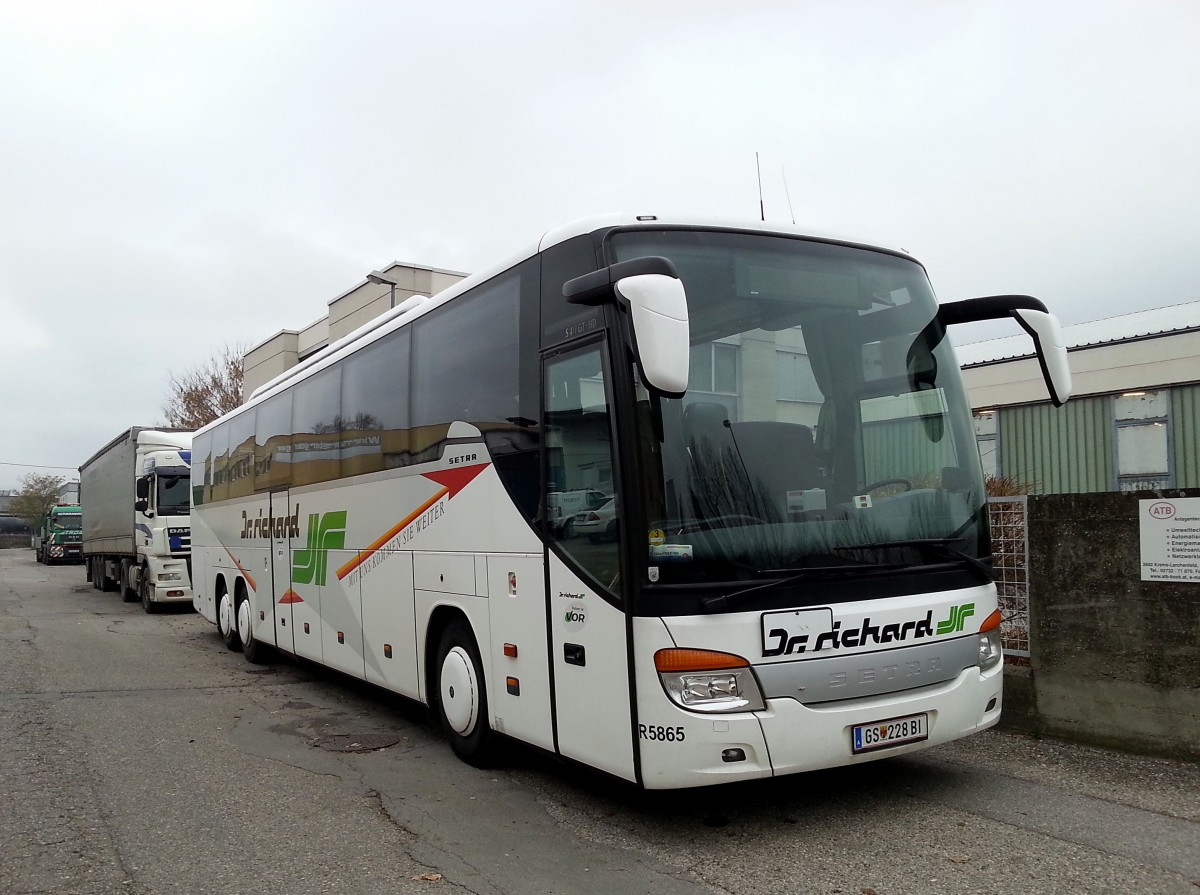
[486,554,554,751]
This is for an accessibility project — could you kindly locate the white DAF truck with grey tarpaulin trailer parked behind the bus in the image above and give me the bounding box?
[79,426,192,612]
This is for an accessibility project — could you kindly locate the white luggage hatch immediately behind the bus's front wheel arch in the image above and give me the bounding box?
[359,551,421,699]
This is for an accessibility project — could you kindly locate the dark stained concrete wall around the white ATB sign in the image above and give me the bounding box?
[1004,489,1200,759]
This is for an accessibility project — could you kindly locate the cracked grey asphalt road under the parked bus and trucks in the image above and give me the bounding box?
[0,549,1200,895]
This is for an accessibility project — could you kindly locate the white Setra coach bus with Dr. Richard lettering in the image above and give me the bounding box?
[192,216,1070,788]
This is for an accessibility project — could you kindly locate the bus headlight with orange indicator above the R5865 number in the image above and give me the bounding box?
[654,649,766,713]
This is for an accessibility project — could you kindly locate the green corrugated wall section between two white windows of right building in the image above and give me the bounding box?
[1000,395,1108,494]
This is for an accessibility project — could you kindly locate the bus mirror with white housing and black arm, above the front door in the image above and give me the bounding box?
[563,256,691,397]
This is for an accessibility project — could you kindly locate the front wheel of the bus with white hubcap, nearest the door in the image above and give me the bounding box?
[434,618,497,768]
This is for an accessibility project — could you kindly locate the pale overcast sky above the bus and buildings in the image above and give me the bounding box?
[0,0,1200,488]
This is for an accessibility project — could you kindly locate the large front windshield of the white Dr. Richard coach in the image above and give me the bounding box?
[610,229,989,591]
